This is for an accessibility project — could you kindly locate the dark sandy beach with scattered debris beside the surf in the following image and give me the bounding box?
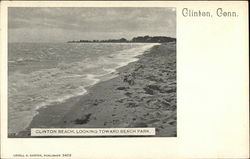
[17,42,177,137]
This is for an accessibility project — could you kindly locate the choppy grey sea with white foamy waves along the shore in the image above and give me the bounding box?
[8,43,157,133]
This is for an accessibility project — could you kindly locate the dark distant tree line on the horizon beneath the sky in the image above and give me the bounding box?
[68,35,176,43]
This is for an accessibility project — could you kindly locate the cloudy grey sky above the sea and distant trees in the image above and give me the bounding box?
[8,7,176,42]
